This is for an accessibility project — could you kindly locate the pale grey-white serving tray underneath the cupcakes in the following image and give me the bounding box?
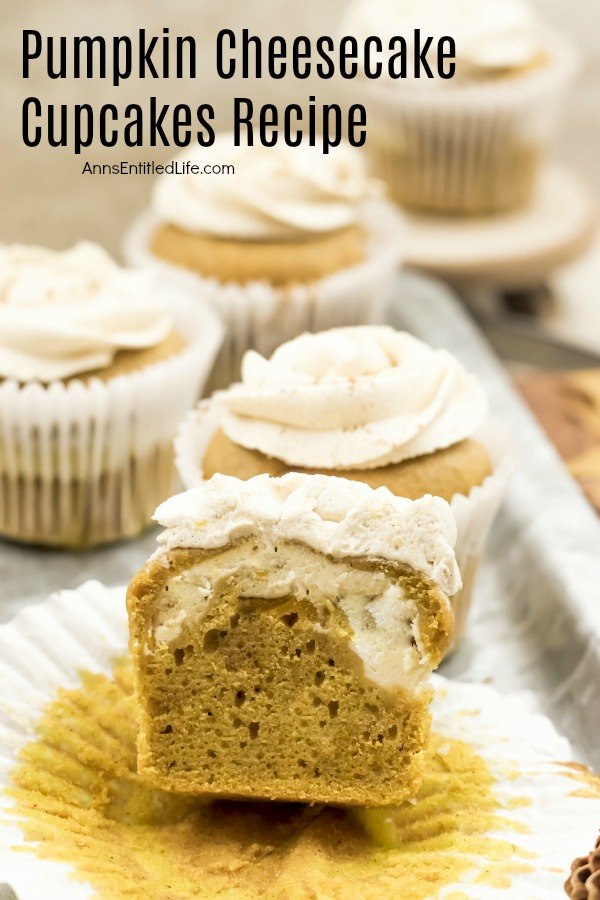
[0,273,600,769]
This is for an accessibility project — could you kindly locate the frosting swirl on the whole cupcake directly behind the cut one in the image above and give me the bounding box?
[219,326,487,470]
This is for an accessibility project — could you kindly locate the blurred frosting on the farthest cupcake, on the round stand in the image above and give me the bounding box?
[342,0,546,83]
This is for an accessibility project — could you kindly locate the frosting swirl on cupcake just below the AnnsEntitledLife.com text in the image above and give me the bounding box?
[153,132,378,241]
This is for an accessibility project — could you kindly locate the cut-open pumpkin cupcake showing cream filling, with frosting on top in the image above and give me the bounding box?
[128,474,460,806]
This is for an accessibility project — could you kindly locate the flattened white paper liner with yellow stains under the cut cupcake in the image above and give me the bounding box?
[0,582,600,900]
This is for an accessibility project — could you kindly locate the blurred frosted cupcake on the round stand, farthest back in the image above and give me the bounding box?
[342,0,576,215]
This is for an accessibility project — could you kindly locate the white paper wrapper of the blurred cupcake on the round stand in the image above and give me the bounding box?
[352,39,577,215]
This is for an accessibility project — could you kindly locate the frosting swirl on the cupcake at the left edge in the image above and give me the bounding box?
[0,243,171,382]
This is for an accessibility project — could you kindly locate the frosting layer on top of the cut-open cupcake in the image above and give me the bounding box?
[154,472,460,595]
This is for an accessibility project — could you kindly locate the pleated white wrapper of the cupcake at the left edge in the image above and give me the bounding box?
[0,295,222,548]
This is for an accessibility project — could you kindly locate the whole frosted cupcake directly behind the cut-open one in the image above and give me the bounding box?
[176,326,510,652]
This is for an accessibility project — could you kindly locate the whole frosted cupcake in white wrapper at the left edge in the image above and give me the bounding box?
[0,243,222,548]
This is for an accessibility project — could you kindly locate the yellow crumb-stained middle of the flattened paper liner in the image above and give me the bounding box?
[4,661,532,900]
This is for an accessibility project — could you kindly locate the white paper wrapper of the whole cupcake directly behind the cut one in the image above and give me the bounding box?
[174,404,514,650]
